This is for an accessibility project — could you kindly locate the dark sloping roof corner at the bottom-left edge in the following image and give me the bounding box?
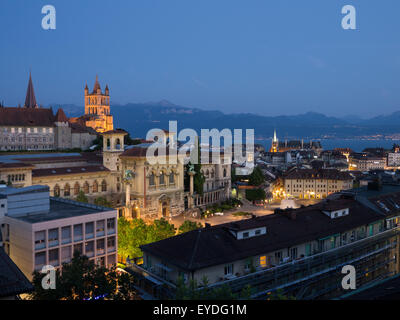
[0,247,33,297]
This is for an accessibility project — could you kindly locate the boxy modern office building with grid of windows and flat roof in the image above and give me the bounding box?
[0,185,117,278]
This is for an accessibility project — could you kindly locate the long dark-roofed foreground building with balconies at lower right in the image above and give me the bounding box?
[131,185,400,299]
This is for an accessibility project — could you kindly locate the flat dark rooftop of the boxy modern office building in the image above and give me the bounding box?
[11,198,115,224]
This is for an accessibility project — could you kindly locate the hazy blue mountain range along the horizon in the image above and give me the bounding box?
[49,100,400,139]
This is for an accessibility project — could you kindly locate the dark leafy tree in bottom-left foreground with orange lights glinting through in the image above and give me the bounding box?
[30,251,135,300]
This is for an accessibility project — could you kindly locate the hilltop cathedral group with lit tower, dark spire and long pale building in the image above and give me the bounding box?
[0,75,113,151]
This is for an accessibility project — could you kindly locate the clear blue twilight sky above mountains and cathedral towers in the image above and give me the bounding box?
[0,0,400,117]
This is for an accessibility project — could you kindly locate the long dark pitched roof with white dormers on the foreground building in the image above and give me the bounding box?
[141,199,383,271]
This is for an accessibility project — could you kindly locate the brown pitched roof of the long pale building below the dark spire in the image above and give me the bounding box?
[0,107,54,127]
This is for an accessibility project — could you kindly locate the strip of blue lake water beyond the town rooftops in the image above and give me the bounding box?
[255,139,400,152]
